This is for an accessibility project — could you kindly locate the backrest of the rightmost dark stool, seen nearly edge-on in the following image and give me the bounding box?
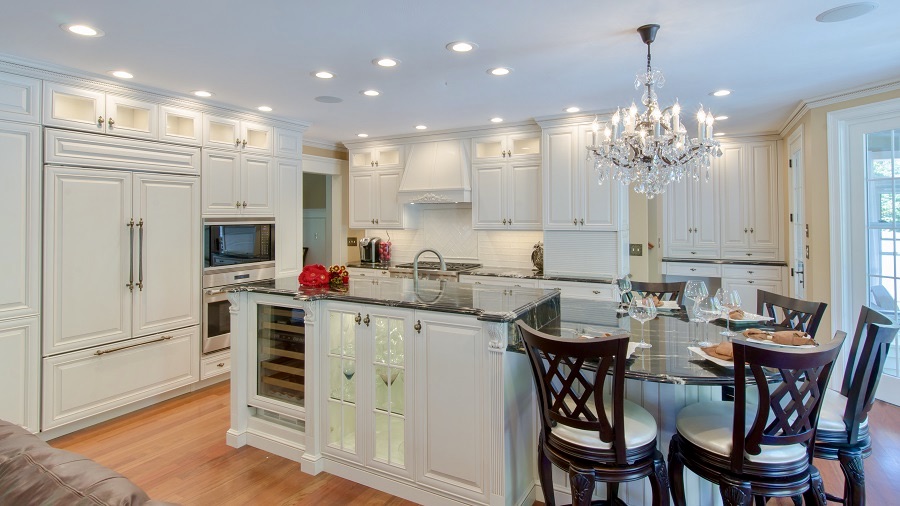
[841,306,897,445]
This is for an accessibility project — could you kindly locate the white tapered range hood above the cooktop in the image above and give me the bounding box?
[398,140,472,204]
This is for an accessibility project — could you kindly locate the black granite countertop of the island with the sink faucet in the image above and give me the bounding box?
[230,277,559,322]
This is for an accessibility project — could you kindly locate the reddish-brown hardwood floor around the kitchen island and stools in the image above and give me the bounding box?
[50,381,900,506]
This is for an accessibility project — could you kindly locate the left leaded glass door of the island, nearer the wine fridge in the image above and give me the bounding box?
[325,305,363,455]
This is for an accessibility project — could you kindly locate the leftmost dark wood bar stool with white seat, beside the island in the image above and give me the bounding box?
[516,320,669,506]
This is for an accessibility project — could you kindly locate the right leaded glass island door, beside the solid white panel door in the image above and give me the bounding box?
[365,308,415,476]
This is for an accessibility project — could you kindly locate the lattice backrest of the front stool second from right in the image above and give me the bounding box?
[731,331,847,473]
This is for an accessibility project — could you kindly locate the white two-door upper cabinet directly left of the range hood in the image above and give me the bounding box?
[350,170,406,229]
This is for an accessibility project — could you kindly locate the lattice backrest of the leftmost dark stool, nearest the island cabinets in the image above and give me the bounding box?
[516,320,628,465]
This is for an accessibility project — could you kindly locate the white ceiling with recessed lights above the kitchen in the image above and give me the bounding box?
[0,0,900,141]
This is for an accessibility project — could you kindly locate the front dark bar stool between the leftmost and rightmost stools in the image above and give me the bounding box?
[669,331,846,506]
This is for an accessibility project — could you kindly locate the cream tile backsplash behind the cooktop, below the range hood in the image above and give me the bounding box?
[366,205,544,268]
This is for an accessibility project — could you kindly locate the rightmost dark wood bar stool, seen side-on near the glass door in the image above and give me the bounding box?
[815,306,897,506]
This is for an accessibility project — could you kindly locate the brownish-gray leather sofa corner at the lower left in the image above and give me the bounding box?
[0,420,176,506]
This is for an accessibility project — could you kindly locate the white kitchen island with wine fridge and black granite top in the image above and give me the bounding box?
[227,278,560,505]
